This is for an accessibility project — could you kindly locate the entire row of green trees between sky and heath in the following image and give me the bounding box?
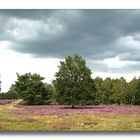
[0,54,140,108]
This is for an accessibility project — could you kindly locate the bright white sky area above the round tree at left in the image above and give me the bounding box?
[0,42,60,92]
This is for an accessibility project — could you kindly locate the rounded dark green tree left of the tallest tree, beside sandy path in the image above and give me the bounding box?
[14,73,48,104]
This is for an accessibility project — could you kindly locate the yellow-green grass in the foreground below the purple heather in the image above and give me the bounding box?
[0,104,140,131]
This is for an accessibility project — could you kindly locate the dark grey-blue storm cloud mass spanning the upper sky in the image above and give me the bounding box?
[0,10,140,71]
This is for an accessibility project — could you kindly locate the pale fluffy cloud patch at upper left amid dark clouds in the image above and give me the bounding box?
[6,17,63,41]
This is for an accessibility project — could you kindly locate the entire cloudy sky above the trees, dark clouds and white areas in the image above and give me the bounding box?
[0,9,140,92]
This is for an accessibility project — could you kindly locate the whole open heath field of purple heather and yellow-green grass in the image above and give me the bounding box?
[0,100,140,131]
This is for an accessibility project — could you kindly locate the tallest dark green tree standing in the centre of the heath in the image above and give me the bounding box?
[53,54,95,108]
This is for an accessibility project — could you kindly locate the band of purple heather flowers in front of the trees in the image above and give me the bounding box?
[14,105,140,115]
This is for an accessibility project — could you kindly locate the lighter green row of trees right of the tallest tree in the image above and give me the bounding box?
[94,77,140,105]
